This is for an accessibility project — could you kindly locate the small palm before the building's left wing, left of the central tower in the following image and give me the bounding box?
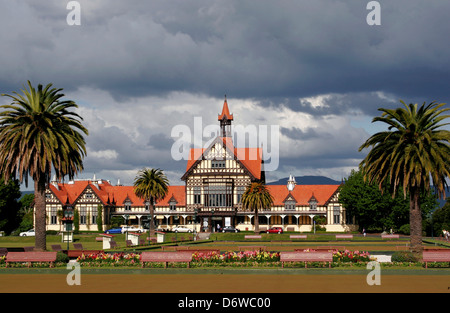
[134,168,169,234]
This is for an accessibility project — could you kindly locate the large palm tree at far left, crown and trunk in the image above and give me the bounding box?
[0,81,88,251]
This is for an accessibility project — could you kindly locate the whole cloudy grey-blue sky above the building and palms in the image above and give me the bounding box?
[0,0,450,189]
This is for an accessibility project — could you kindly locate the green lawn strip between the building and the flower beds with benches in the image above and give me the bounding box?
[0,232,450,252]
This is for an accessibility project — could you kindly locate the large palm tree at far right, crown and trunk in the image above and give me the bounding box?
[359,101,450,259]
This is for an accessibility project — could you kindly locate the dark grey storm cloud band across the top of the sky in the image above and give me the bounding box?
[0,0,450,105]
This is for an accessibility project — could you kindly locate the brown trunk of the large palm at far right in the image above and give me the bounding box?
[409,187,423,261]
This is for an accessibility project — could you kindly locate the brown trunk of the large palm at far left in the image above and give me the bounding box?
[34,178,47,251]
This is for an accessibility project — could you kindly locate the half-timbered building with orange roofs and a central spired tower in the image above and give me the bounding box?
[40,99,355,231]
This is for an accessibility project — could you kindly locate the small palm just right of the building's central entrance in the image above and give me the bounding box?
[242,182,273,233]
